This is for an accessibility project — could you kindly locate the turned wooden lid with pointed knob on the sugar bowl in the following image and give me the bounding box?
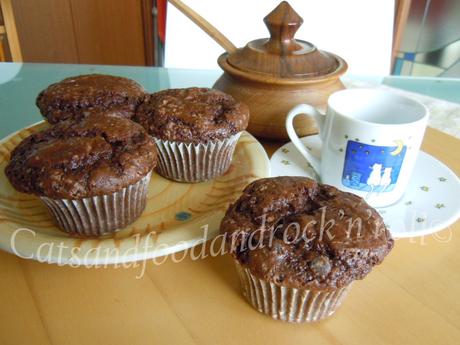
[223,1,347,79]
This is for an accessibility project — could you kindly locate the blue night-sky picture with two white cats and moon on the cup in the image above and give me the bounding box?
[342,140,407,193]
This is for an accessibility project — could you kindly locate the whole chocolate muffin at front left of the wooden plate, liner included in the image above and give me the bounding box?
[5,113,157,236]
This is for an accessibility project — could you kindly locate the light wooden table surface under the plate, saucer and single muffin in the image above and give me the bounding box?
[0,129,460,345]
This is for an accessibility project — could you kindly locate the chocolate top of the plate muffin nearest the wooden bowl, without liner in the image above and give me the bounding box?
[134,87,249,144]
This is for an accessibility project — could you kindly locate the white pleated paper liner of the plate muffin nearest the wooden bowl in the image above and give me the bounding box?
[154,132,241,183]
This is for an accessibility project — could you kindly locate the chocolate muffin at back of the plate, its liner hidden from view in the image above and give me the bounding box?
[36,74,145,124]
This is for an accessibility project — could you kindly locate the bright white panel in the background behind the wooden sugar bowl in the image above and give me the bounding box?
[165,0,394,75]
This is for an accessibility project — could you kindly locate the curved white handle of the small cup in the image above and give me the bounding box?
[286,104,326,176]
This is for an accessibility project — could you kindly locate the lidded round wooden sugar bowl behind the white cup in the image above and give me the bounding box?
[214,1,347,141]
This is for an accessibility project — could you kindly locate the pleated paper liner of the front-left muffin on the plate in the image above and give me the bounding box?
[40,172,152,236]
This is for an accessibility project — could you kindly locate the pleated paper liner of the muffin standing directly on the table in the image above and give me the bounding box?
[235,261,350,323]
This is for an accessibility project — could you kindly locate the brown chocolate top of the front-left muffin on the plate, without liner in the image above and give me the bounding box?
[5,114,156,199]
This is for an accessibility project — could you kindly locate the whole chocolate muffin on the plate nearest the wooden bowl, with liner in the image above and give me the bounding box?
[133,87,249,182]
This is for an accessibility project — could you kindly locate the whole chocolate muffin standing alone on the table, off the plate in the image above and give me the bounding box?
[221,177,394,322]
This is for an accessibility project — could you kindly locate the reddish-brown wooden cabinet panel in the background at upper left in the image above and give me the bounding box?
[4,0,154,65]
